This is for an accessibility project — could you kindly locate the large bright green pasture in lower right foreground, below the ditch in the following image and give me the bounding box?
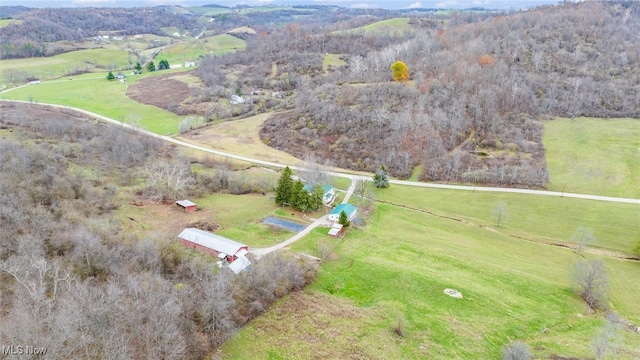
[223,195,640,359]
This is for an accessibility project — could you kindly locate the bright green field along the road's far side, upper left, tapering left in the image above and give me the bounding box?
[2,70,183,135]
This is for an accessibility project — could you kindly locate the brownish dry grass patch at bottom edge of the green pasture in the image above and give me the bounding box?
[222,292,418,359]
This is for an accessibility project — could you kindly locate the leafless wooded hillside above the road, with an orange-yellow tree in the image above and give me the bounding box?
[258,1,640,187]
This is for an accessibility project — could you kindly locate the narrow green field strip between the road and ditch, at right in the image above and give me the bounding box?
[376,186,640,256]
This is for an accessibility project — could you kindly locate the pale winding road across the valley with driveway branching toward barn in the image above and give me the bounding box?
[0,97,640,257]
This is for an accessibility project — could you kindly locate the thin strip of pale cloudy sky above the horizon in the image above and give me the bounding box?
[5,0,560,9]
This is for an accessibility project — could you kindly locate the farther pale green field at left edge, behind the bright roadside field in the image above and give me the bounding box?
[0,49,136,83]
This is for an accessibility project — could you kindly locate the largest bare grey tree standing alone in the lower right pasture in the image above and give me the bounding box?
[573,259,608,310]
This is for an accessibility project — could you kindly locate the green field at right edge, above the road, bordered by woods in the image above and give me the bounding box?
[543,118,640,199]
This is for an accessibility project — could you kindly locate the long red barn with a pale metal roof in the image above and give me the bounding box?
[178,228,249,263]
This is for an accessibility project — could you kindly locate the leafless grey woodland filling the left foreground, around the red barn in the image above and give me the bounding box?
[0,102,316,359]
